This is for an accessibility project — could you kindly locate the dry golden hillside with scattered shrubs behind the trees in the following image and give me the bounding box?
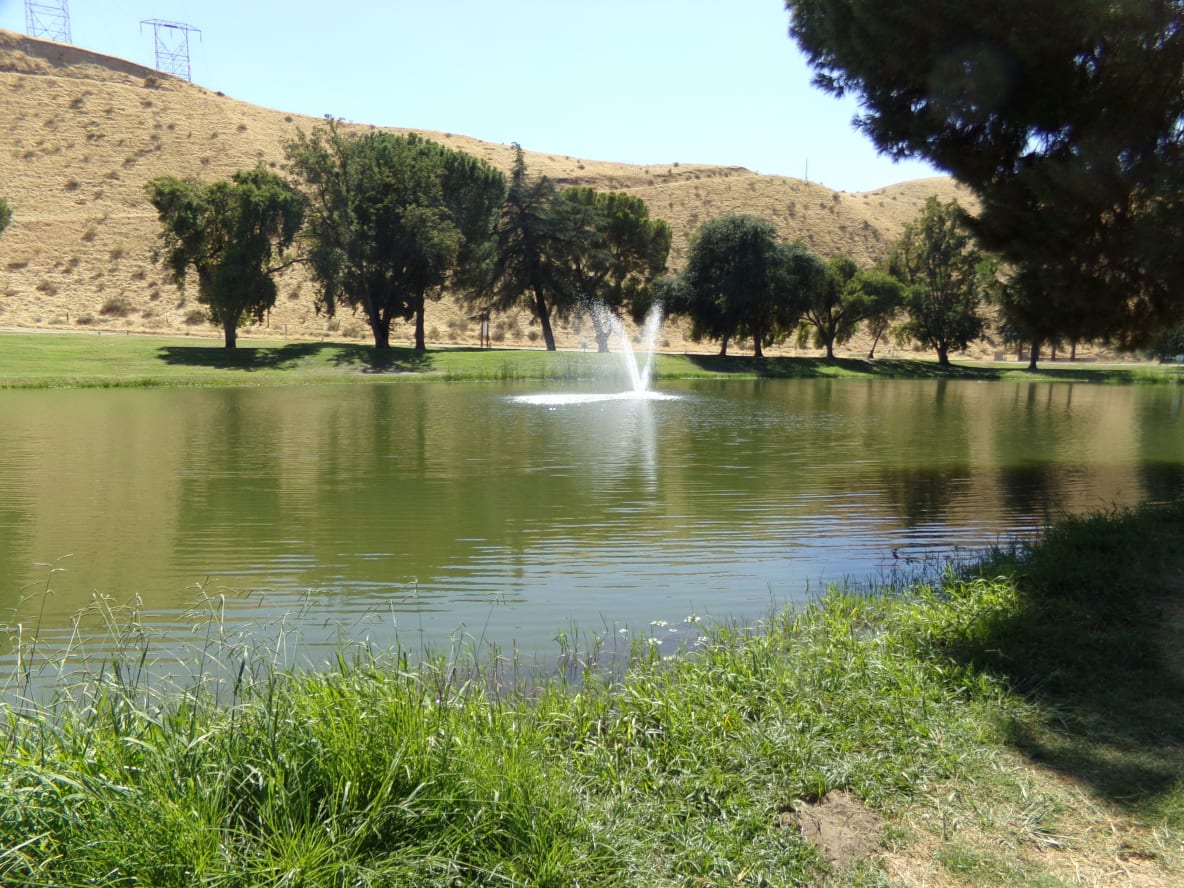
[0,31,965,350]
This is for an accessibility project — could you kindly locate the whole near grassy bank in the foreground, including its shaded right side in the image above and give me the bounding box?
[0,504,1184,887]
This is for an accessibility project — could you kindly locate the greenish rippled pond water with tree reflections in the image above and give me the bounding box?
[0,380,1184,662]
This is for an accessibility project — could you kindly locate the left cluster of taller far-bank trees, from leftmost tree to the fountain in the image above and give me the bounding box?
[147,126,671,349]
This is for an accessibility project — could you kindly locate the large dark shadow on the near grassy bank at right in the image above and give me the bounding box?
[946,502,1184,828]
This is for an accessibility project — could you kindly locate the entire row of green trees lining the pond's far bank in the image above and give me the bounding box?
[147,120,1108,365]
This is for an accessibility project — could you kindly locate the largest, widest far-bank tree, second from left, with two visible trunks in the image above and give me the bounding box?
[285,120,506,349]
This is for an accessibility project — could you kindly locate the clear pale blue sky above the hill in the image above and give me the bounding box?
[0,0,937,191]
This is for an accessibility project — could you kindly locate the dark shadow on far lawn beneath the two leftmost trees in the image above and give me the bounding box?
[159,342,432,373]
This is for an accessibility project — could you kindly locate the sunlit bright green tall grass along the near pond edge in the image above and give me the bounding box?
[0,594,990,886]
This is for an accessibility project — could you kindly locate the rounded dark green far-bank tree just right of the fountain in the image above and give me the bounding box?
[662,214,825,358]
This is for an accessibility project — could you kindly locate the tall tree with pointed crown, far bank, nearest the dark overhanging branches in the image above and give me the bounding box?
[889,198,992,367]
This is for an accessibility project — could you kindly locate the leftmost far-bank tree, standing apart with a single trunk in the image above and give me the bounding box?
[146,167,304,348]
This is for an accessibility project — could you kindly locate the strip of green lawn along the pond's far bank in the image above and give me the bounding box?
[0,333,1184,388]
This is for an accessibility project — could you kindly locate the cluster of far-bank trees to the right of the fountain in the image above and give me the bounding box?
[658,198,997,366]
